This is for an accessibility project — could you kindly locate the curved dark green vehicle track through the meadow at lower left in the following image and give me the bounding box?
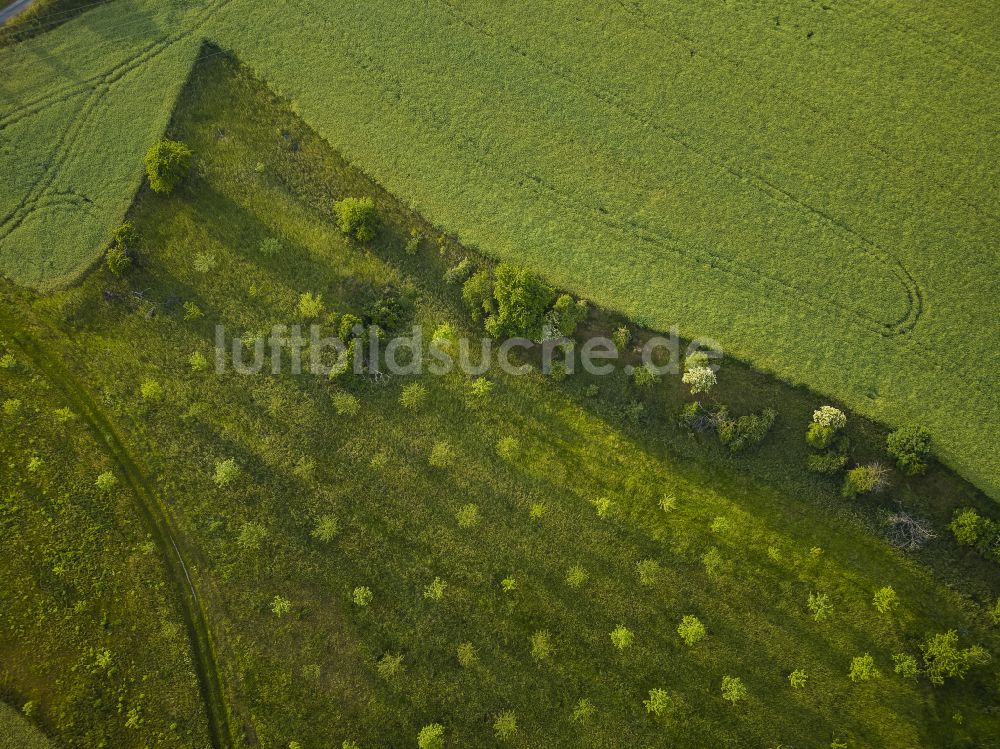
[0,309,239,749]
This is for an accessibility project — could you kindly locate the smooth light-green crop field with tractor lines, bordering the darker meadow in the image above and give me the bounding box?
[0,0,1000,496]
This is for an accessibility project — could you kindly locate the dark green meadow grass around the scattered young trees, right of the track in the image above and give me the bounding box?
[5,58,997,748]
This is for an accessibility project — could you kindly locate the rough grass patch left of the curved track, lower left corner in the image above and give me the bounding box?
[0,322,207,747]
